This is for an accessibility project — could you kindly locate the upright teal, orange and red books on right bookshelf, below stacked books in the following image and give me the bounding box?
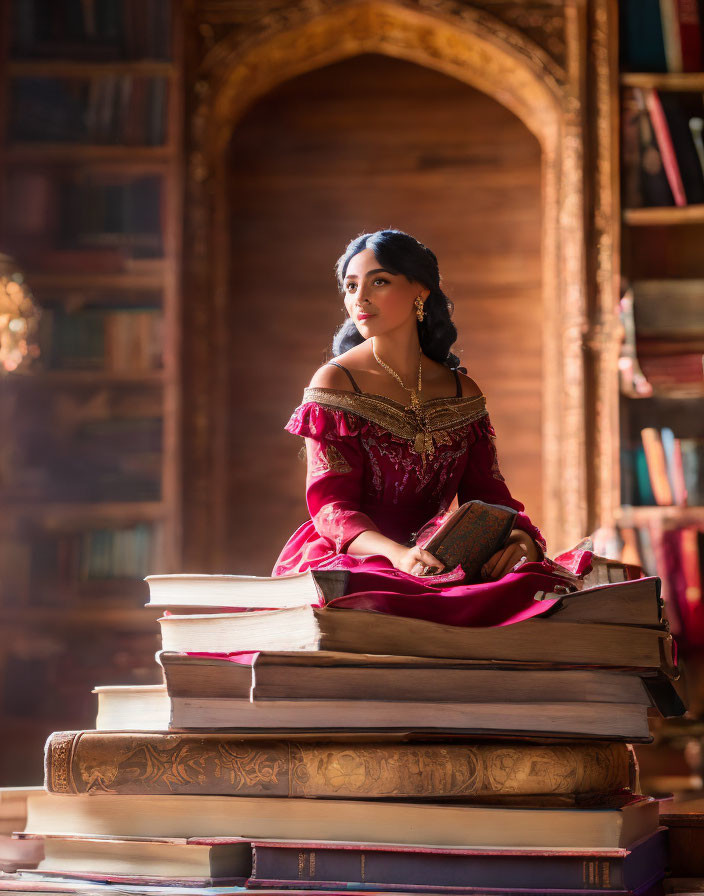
[621,427,704,507]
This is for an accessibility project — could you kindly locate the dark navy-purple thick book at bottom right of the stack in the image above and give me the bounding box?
[247,828,667,893]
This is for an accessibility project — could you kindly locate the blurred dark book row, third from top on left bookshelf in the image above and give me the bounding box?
[6,169,163,256]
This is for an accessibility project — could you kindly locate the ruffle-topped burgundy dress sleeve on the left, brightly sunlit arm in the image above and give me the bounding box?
[286,402,379,554]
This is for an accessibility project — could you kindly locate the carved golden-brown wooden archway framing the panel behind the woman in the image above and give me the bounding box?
[183,0,600,569]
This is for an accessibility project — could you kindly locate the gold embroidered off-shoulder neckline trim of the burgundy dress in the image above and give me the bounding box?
[303,387,487,461]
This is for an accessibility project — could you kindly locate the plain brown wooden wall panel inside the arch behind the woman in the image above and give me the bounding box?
[223,55,542,574]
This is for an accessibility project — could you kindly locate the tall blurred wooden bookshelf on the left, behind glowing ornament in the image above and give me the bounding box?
[0,0,183,785]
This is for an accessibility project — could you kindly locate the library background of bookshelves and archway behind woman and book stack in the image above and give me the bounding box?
[0,0,704,856]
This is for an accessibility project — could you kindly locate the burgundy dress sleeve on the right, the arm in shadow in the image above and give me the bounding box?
[457,416,546,555]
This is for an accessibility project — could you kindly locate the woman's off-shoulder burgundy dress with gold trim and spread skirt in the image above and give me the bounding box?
[272,362,567,626]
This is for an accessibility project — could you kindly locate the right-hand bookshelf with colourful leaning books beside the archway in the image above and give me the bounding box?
[615,0,704,660]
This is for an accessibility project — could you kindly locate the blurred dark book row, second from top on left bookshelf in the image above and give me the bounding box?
[9,75,168,146]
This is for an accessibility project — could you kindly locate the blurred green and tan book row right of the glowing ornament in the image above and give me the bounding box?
[39,306,163,373]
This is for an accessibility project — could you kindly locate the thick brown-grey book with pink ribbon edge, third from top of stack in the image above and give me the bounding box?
[158,651,646,703]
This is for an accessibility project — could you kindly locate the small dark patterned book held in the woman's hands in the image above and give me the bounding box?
[416,501,517,582]
